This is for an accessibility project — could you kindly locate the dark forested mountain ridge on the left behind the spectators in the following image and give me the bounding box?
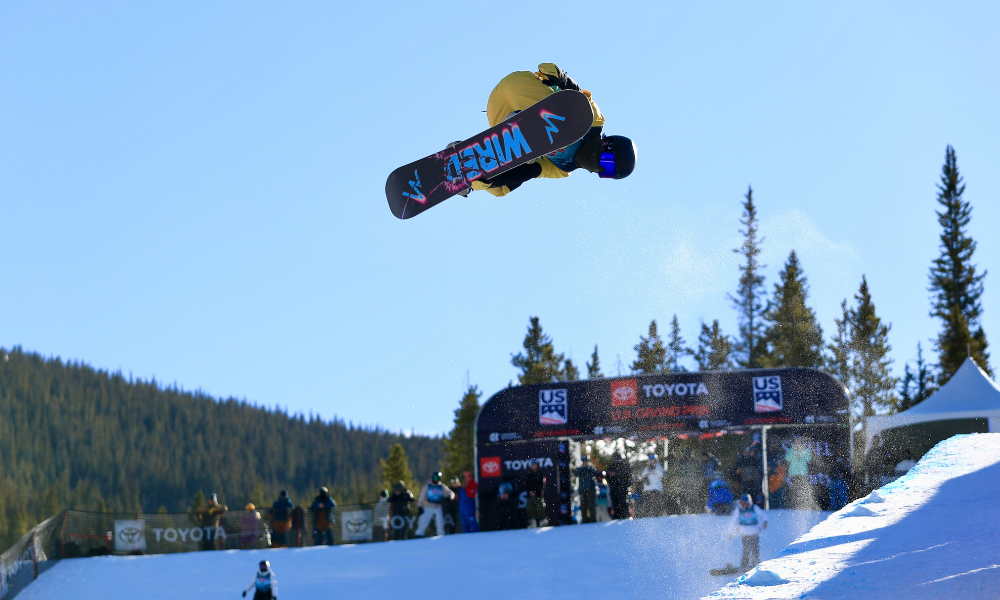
[0,347,443,548]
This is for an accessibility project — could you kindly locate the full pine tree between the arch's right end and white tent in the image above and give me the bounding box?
[849,277,897,418]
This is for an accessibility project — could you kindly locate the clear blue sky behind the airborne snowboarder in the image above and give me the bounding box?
[0,1,1000,432]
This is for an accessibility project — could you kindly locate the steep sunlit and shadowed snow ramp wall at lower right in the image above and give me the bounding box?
[708,433,1000,600]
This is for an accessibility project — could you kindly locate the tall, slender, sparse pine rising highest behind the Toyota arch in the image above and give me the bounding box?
[729,188,767,369]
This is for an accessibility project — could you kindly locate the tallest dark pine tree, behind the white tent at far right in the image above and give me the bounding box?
[929,146,993,385]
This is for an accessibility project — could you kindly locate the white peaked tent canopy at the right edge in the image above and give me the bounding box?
[865,358,1000,448]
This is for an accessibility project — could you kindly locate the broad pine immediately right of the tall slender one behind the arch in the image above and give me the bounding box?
[761,250,823,368]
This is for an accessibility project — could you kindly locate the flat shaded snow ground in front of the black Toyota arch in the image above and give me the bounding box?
[17,511,830,600]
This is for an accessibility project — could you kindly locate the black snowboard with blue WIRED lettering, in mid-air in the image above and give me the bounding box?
[385,90,594,219]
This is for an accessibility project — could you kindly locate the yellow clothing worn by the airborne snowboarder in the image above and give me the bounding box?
[472,63,604,196]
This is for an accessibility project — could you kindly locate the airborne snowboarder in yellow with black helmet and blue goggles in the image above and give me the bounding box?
[461,63,636,196]
